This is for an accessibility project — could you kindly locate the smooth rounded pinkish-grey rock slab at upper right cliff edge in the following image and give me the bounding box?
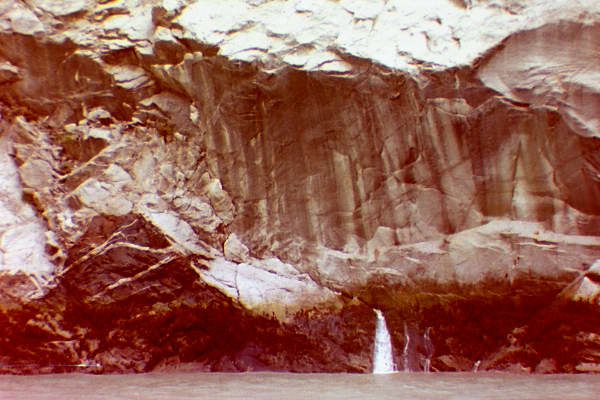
[478,22,600,137]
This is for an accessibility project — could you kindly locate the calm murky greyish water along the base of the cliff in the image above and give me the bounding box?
[0,372,600,400]
